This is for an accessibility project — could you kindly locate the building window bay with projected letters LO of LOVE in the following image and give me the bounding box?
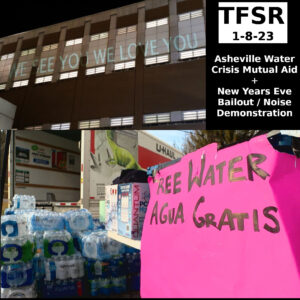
[114,25,137,71]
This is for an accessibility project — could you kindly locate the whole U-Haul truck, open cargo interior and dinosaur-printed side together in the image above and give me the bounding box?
[8,130,183,218]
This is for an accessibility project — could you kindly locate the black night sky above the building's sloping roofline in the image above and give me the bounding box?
[0,0,140,37]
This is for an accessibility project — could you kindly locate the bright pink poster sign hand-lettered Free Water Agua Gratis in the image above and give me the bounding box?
[141,135,300,298]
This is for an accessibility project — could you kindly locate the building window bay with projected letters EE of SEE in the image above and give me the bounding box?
[36,44,58,77]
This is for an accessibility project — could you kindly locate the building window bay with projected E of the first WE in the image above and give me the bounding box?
[14,49,35,81]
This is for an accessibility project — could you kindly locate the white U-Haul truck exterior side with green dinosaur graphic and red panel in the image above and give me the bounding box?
[80,130,183,216]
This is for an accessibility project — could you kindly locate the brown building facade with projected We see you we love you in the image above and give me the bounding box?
[0,0,206,130]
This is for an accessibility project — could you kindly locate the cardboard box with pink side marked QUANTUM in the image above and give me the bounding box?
[117,183,150,240]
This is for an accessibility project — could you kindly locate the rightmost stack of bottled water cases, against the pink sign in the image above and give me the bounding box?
[81,231,140,296]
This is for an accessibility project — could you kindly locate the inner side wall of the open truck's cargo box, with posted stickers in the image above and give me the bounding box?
[14,131,80,202]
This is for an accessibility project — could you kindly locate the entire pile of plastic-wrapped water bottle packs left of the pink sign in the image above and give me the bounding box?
[0,195,140,298]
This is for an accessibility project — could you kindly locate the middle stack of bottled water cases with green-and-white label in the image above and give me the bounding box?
[29,211,84,298]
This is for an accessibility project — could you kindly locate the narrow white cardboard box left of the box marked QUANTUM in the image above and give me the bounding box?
[105,184,118,232]
